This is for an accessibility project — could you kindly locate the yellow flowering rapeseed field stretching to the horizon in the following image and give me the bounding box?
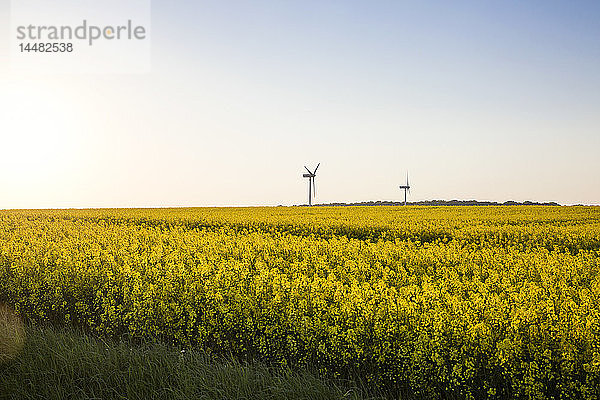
[0,206,600,399]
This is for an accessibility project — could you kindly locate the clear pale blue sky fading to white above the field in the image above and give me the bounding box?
[0,0,600,209]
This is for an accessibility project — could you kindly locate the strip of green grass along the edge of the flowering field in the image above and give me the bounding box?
[0,327,384,400]
